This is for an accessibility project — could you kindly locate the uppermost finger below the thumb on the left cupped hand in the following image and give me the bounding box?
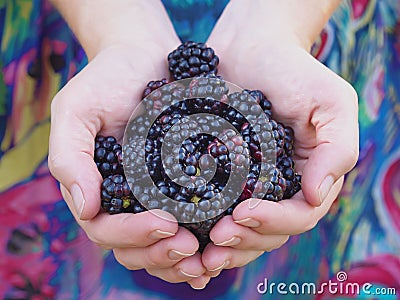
[61,186,178,248]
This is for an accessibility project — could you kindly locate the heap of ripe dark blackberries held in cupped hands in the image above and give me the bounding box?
[94,42,301,252]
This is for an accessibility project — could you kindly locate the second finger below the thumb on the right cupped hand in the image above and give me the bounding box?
[210,216,289,252]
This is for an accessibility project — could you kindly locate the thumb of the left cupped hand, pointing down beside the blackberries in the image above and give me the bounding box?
[48,85,102,220]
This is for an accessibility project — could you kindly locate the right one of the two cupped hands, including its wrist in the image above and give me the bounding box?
[202,0,358,275]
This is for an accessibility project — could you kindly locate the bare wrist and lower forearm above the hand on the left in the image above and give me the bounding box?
[52,0,178,60]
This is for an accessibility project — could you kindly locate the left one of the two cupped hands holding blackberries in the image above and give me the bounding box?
[48,9,210,288]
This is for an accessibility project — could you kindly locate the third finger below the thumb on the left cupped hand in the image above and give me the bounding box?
[146,252,205,283]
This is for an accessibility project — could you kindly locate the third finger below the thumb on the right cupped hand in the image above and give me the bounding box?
[201,244,264,272]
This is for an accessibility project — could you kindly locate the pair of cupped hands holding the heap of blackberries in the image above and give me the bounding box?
[49,1,358,289]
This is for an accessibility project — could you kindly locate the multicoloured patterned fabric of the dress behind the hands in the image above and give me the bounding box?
[0,0,400,300]
